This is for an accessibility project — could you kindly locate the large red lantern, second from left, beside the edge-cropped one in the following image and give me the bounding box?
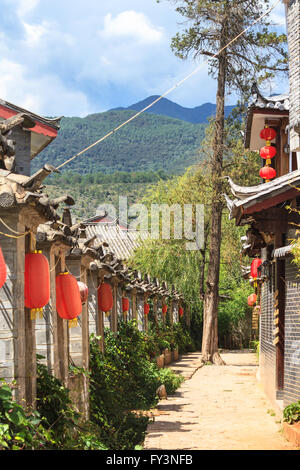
[24,251,50,319]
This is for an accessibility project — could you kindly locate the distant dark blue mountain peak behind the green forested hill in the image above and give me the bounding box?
[116,95,235,124]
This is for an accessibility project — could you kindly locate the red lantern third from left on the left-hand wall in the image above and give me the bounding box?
[56,273,82,320]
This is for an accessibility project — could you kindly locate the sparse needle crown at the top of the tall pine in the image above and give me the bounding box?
[171,0,288,94]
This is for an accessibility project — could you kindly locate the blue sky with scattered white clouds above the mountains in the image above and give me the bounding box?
[0,0,285,116]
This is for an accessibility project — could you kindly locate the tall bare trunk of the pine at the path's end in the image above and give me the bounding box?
[202,35,226,365]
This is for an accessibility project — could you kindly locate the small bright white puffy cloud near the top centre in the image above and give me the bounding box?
[100,10,164,44]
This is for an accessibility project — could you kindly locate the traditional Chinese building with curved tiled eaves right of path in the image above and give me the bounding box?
[226,0,300,409]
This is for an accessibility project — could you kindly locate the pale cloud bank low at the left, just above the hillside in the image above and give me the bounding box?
[0,59,89,116]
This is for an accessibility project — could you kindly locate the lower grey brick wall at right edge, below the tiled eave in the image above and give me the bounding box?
[284,258,300,406]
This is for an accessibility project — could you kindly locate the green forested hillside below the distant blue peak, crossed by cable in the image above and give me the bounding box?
[32,110,206,174]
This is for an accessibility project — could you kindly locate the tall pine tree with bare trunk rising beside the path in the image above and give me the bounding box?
[163,0,288,364]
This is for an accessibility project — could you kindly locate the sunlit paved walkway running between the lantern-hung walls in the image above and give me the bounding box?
[144,351,294,450]
